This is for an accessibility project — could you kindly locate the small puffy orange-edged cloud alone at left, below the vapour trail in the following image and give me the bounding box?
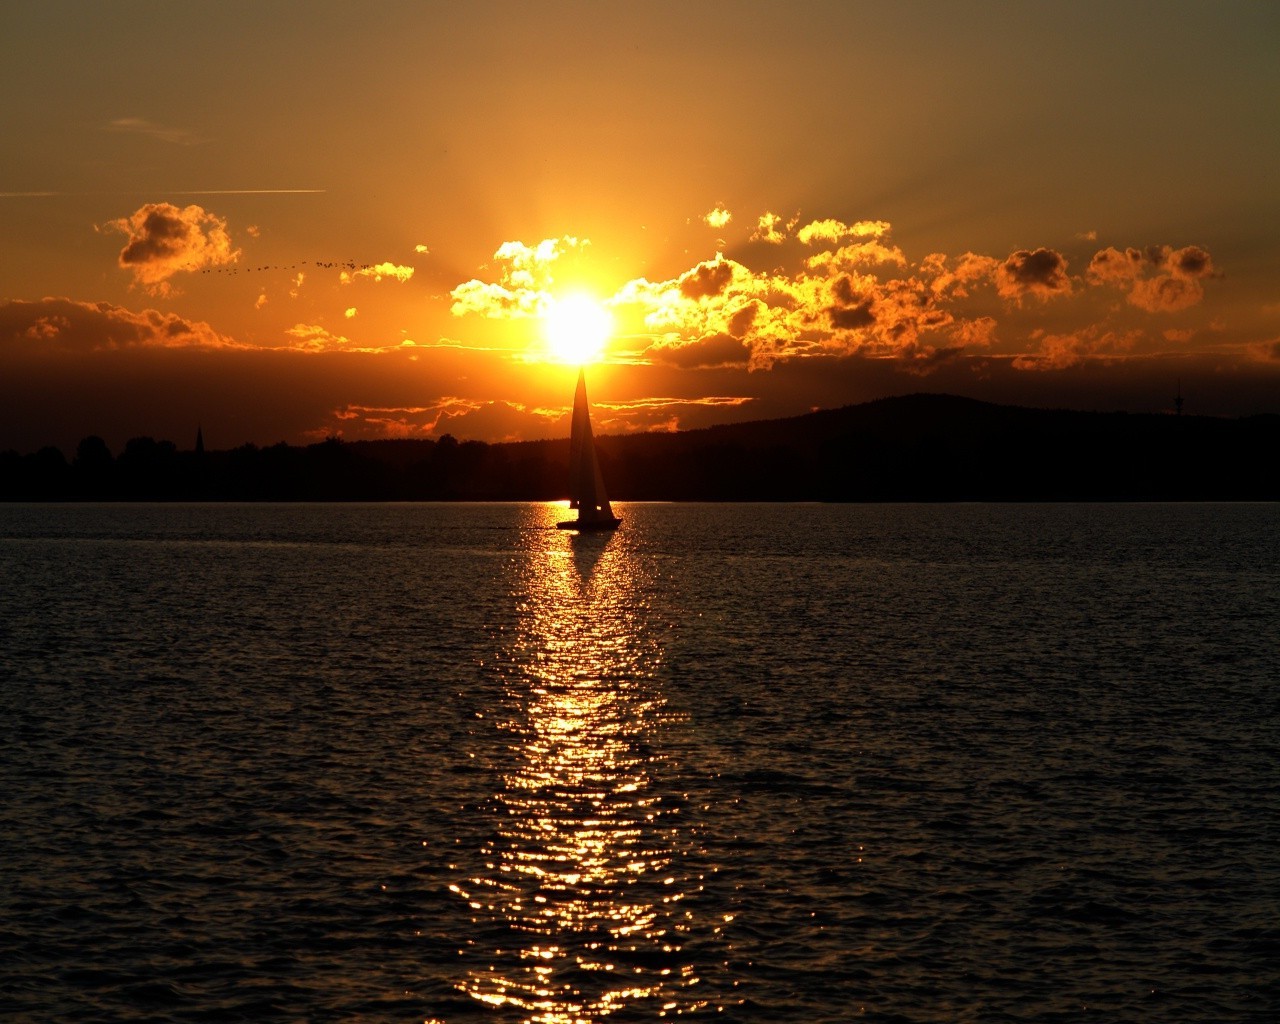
[106,202,241,296]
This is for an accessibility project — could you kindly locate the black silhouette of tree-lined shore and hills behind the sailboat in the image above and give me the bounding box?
[0,394,1280,502]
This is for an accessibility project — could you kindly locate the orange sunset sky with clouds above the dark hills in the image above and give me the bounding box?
[0,0,1280,454]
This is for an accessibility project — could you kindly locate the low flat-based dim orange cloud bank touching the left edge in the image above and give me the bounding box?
[0,298,235,353]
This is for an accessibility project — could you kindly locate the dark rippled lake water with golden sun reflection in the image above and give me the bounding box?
[0,504,1280,1024]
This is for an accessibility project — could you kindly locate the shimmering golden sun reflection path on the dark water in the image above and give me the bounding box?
[454,506,718,1024]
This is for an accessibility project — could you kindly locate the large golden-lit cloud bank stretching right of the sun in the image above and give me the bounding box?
[611,214,1216,372]
